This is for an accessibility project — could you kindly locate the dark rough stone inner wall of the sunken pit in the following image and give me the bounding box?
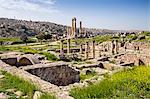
[26,65,80,86]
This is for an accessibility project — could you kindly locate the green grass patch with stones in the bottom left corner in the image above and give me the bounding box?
[0,71,55,99]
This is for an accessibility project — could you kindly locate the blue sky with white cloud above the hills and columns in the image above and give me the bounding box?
[0,0,150,30]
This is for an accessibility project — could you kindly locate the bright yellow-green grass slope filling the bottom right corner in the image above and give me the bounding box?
[70,66,150,99]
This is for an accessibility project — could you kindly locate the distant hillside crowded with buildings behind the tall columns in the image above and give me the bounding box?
[0,18,141,37]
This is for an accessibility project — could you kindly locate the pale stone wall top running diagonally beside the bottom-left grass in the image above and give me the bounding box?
[0,60,61,98]
